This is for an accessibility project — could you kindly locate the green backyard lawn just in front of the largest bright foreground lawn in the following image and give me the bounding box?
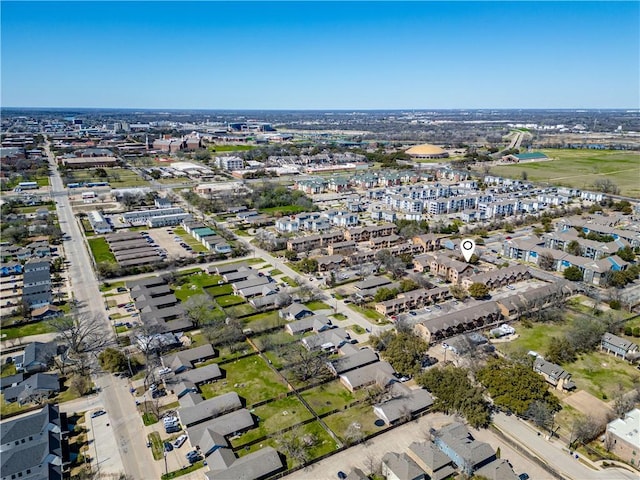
[231,395,313,447]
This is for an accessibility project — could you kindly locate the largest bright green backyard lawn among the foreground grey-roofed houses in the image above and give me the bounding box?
[201,355,287,406]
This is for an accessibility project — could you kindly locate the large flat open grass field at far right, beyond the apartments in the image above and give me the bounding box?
[484,150,640,198]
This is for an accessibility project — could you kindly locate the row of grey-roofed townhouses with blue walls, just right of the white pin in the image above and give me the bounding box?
[503,238,629,285]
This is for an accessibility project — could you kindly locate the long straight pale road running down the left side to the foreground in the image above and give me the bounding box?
[45,143,150,480]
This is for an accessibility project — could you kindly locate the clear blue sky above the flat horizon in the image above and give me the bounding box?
[0,0,640,109]
